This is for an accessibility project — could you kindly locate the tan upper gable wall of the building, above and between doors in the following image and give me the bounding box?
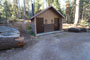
[37,9,60,24]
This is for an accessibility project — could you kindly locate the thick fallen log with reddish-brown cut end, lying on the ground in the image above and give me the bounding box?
[0,37,24,50]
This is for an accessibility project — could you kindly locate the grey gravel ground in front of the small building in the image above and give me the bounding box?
[0,32,90,60]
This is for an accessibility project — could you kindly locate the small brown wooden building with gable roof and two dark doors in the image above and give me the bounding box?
[31,6,64,35]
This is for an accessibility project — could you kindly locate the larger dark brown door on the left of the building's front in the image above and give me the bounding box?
[36,18,44,33]
